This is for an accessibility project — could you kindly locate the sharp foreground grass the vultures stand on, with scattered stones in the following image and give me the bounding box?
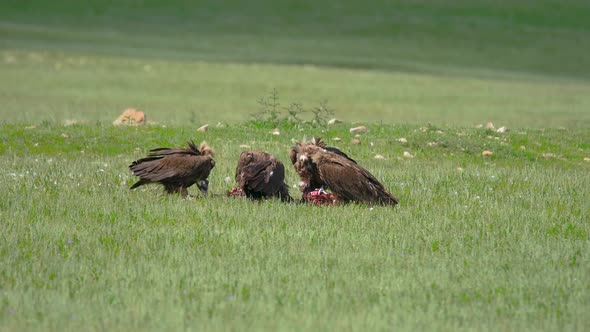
[0,125,590,330]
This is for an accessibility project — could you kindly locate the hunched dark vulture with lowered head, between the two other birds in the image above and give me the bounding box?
[230,150,292,202]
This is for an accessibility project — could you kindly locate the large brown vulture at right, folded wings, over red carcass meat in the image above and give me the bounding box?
[290,138,398,205]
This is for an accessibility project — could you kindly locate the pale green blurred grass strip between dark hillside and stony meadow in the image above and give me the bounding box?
[0,51,590,128]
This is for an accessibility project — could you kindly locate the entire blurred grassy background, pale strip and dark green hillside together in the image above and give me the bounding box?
[0,1,590,127]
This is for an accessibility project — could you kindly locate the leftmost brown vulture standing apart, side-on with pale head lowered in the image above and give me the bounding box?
[129,141,215,197]
